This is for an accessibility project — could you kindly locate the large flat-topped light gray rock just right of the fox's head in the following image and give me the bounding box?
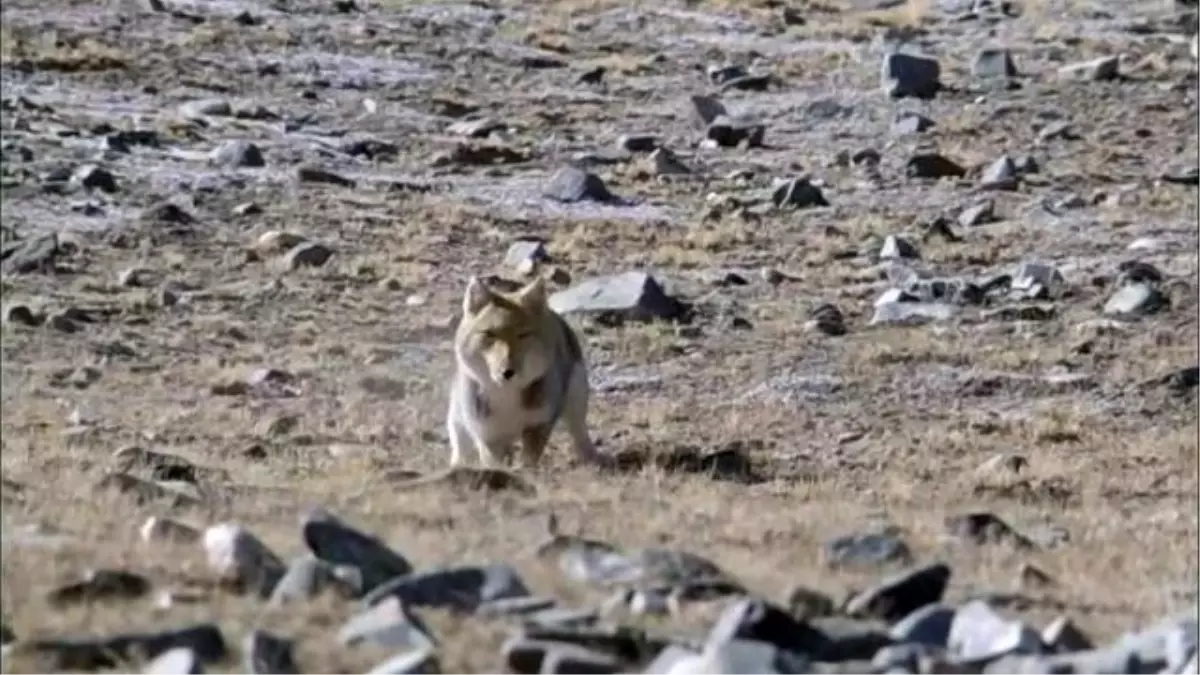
[550,271,683,321]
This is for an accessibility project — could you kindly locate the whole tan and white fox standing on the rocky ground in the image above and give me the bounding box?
[446,277,601,466]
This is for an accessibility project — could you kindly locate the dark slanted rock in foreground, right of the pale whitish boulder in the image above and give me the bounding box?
[302,508,413,593]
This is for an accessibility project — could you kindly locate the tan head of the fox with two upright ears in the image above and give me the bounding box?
[455,276,554,387]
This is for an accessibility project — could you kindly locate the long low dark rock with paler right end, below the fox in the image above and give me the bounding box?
[364,563,529,613]
